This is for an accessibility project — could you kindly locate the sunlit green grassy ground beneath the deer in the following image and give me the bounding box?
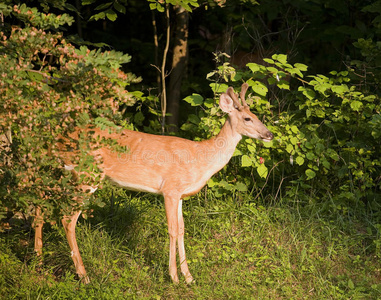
[0,190,381,299]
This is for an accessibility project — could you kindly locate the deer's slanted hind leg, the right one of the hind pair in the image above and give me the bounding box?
[62,211,90,284]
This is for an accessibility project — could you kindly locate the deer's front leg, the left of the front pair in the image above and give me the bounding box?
[164,196,180,283]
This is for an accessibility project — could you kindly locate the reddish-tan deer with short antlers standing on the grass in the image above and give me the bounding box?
[31,83,274,284]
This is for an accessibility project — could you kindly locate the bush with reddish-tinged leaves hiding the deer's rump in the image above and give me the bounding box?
[0,4,139,219]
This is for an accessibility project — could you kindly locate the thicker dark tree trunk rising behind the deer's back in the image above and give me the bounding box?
[167,5,189,132]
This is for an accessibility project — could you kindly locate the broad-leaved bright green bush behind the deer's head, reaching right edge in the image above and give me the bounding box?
[182,55,381,211]
